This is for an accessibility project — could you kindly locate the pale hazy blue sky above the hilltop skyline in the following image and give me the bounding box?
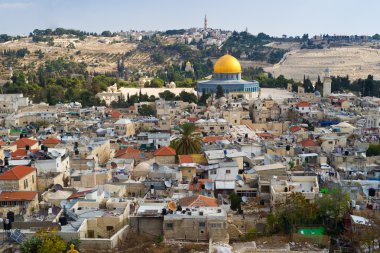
[0,0,380,35]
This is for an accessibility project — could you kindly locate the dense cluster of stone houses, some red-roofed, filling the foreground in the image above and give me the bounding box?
[0,89,380,251]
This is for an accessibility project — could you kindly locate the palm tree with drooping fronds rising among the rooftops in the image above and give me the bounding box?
[170,123,202,155]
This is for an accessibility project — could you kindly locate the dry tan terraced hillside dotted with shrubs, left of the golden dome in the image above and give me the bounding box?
[0,35,161,79]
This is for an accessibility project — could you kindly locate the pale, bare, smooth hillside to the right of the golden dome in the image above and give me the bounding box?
[264,43,380,80]
